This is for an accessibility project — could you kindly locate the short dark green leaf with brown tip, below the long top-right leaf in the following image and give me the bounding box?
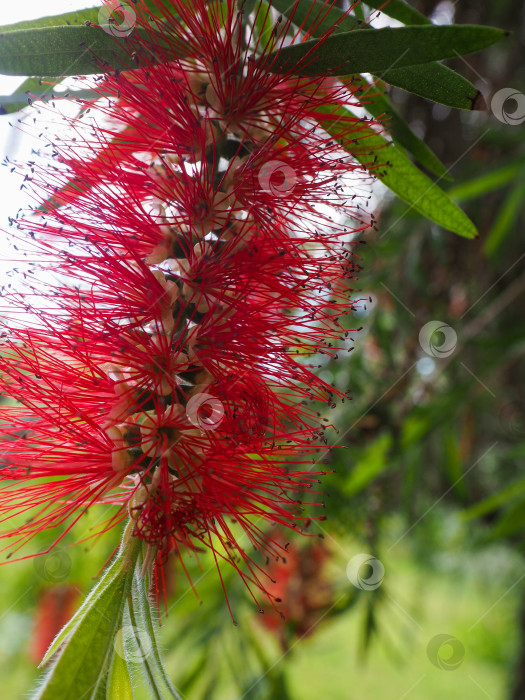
[372,62,486,110]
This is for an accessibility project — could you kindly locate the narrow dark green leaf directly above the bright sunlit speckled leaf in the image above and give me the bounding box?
[359,79,452,180]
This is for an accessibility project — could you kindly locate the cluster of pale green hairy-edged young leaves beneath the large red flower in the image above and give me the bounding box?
[32,525,180,700]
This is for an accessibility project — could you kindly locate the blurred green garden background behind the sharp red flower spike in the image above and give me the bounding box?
[0,0,525,700]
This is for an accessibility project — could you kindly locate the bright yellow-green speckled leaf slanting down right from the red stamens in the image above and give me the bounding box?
[315,107,477,238]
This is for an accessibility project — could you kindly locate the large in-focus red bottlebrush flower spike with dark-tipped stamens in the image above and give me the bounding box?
[0,0,376,608]
